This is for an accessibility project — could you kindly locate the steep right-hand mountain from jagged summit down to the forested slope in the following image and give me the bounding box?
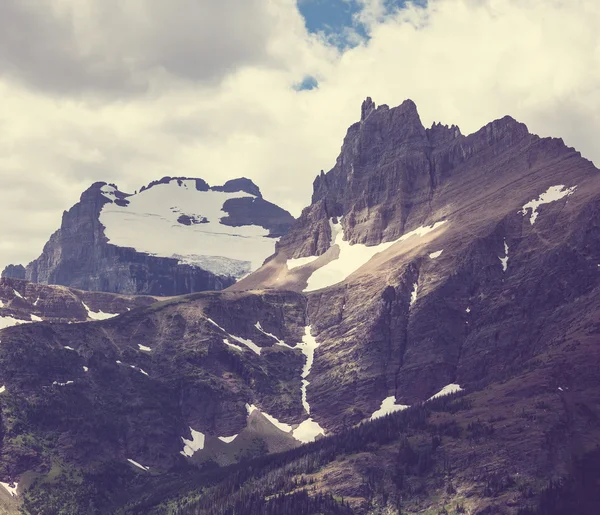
[233,95,600,430]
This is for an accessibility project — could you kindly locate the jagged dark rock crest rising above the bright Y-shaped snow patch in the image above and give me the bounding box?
[236,98,592,298]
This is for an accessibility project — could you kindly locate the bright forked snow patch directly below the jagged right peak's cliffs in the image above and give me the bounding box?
[304,218,446,292]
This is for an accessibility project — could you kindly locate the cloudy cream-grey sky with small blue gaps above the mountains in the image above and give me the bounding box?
[0,0,600,267]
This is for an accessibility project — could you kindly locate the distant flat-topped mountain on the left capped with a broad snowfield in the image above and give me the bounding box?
[3,177,293,296]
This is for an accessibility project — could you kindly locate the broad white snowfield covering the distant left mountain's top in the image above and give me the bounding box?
[100,179,277,277]
